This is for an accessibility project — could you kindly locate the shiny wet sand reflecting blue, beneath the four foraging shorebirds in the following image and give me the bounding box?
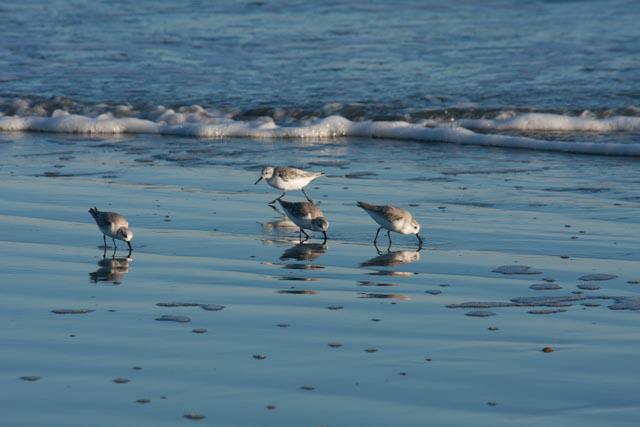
[0,134,640,426]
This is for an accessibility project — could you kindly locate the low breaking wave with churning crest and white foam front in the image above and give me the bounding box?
[0,101,640,157]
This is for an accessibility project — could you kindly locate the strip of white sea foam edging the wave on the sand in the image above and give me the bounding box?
[0,107,640,156]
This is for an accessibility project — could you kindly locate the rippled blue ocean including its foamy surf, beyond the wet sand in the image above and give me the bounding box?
[0,0,640,156]
